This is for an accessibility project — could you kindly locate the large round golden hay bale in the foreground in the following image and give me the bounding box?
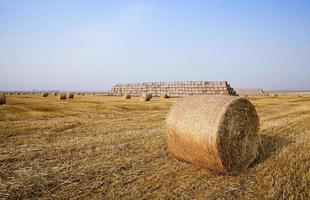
[166,95,259,174]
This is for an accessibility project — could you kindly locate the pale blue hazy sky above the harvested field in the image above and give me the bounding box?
[0,0,310,91]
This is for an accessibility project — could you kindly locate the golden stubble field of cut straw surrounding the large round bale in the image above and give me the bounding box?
[0,94,310,199]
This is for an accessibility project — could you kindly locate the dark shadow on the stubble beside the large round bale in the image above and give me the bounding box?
[250,135,294,167]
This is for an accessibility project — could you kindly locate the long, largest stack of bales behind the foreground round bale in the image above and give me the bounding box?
[110,81,236,97]
